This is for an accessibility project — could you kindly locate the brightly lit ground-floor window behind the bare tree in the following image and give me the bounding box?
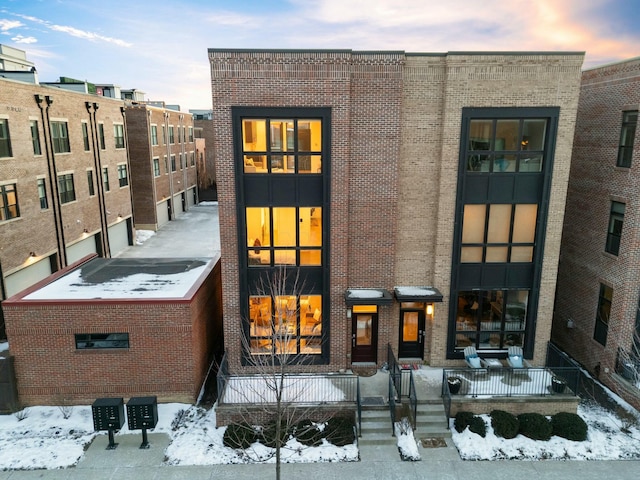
[249,295,322,354]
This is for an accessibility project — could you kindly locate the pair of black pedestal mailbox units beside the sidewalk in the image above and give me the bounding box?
[91,397,158,450]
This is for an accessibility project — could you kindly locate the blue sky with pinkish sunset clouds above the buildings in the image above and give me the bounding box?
[0,0,640,111]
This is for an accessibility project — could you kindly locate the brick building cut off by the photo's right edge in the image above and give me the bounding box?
[552,58,640,406]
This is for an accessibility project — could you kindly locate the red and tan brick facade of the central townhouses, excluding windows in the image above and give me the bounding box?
[209,49,583,371]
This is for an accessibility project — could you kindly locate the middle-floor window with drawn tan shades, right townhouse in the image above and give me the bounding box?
[460,204,538,263]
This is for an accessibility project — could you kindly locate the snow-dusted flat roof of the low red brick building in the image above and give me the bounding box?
[24,259,207,300]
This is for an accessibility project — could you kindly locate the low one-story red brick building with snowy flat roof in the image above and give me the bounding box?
[4,257,222,405]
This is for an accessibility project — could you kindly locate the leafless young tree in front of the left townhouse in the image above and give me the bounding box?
[225,267,354,480]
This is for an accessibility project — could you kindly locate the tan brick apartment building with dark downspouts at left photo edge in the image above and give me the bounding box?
[0,72,133,318]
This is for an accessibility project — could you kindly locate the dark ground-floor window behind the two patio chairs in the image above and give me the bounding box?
[456,290,529,349]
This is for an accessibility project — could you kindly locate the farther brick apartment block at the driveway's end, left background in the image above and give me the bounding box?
[125,102,198,230]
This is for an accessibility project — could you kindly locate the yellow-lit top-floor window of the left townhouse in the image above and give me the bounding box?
[242,119,322,174]
